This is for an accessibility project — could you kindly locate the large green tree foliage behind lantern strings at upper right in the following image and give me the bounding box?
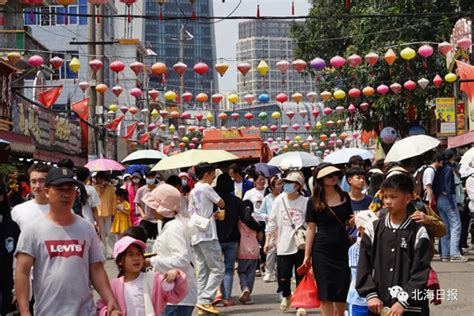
[292,0,474,136]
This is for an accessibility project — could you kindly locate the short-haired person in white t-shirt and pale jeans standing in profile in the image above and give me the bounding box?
[189,163,225,314]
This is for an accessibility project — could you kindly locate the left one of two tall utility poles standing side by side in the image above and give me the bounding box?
[87,3,97,155]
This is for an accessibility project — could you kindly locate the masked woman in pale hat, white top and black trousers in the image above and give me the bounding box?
[264,171,308,311]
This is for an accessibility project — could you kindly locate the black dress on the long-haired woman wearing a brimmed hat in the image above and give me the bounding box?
[306,195,353,303]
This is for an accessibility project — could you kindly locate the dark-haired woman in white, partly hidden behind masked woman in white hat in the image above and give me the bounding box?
[259,176,283,282]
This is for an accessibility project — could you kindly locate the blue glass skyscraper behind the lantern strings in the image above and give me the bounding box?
[143,0,218,96]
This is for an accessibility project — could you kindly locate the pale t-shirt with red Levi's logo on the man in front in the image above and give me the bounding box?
[15,215,105,316]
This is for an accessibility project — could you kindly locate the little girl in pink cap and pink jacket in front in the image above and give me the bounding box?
[97,236,188,316]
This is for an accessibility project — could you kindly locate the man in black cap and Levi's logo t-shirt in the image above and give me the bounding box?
[15,168,118,316]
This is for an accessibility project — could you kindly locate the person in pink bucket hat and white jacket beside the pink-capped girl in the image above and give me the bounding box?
[142,184,197,316]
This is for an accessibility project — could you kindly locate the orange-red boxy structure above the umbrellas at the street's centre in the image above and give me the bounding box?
[202,128,263,159]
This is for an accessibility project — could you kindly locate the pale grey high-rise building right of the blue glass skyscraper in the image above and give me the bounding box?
[237,20,315,99]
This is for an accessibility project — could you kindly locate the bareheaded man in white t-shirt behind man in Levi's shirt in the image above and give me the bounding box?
[11,163,51,230]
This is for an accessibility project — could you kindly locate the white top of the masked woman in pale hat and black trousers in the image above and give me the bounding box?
[265,193,308,256]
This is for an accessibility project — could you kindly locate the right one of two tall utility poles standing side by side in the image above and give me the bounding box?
[96,5,107,158]
